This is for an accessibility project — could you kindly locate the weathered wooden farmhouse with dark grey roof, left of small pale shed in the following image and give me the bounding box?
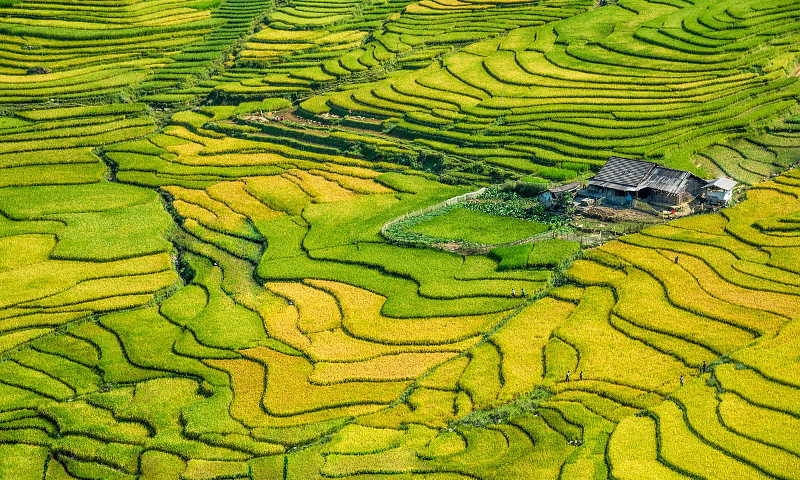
[582,157,707,206]
